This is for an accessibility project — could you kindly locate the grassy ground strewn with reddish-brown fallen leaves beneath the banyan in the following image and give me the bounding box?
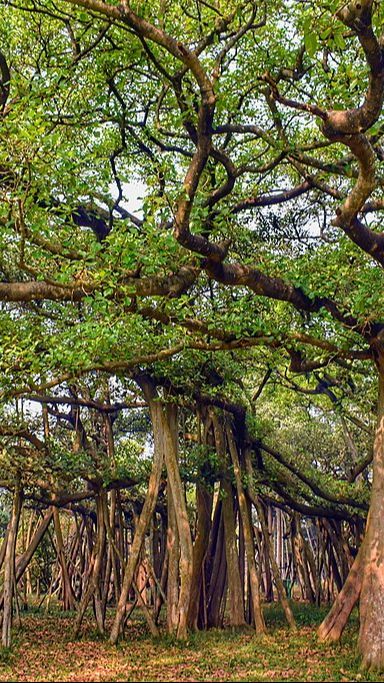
[0,605,384,682]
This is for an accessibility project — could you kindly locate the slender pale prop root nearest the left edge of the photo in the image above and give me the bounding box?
[2,480,23,647]
